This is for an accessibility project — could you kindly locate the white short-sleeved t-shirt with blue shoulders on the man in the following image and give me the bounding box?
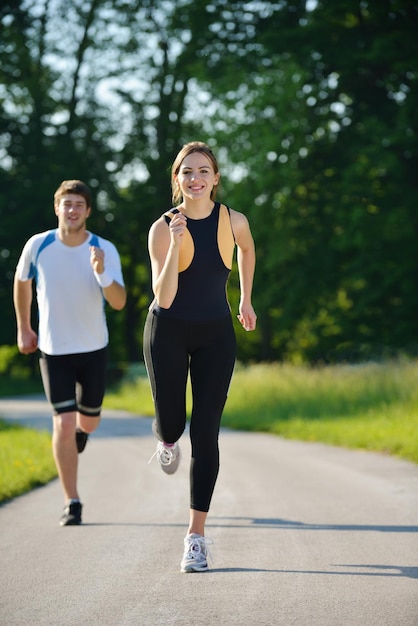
[16,229,124,355]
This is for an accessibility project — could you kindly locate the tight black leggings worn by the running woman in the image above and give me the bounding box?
[144,312,236,512]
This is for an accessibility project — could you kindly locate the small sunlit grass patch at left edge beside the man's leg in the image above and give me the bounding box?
[0,420,57,502]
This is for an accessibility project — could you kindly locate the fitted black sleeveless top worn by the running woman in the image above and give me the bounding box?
[153,202,234,321]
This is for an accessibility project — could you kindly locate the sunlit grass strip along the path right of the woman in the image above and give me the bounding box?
[223,361,418,463]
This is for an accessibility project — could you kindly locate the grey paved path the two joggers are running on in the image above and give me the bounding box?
[0,400,418,626]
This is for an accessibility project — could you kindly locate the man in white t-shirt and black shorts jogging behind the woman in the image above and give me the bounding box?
[13,180,126,526]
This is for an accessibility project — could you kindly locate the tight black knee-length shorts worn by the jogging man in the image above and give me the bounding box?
[39,347,107,417]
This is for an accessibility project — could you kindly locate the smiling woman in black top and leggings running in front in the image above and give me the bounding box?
[144,142,257,572]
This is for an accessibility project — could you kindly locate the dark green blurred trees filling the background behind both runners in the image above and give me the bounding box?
[0,0,418,362]
